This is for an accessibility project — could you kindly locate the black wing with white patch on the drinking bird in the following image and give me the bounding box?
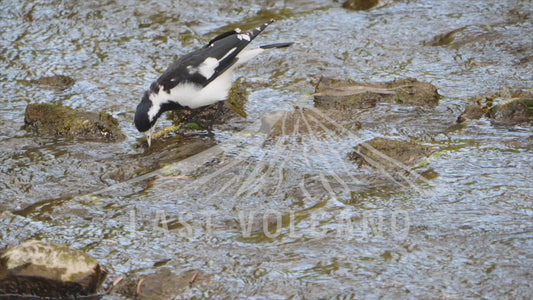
[153,20,273,91]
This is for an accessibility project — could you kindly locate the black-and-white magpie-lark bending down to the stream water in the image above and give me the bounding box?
[135,20,293,146]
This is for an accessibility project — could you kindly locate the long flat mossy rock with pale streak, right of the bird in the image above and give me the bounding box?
[314,78,440,111]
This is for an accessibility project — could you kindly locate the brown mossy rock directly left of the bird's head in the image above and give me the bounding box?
[23,103,125,142]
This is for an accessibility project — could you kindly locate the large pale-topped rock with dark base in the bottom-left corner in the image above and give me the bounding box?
[0,241,108,299]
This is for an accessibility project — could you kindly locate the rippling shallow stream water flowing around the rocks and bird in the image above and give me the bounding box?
[0,0,533,299]
